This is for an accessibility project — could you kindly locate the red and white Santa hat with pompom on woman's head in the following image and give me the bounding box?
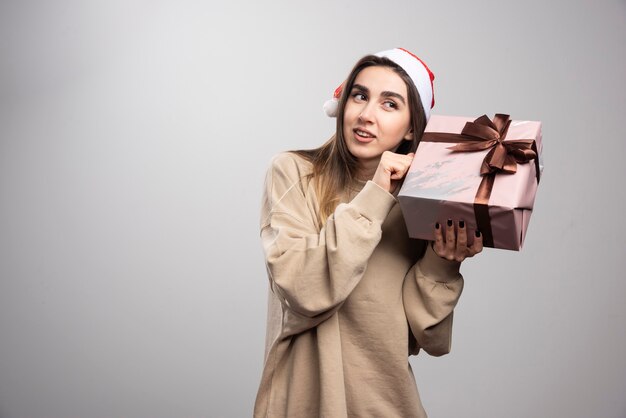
[324,48,435,120]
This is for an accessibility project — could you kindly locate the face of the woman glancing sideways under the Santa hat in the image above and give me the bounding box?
[343,66,412,167]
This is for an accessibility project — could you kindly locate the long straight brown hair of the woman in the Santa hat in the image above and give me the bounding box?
[291,55,426,228]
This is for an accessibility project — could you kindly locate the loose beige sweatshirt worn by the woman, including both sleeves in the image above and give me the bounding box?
[254,153,463,418]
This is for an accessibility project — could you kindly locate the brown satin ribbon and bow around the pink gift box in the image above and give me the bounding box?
[422,113,541,247]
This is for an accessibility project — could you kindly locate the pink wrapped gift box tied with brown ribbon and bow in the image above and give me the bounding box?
[398,114,543,250]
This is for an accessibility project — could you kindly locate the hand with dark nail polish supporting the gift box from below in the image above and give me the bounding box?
[432,219,483,262]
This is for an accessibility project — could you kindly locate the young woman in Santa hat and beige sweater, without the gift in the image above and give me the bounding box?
[254,49,482,418]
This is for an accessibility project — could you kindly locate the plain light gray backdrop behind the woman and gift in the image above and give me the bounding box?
[0,0,626,418]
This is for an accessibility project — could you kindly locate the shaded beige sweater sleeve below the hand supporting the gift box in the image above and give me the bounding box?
[402,245,463,356]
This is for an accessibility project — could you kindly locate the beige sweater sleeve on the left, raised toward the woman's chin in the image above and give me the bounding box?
[261,153,395,333]
